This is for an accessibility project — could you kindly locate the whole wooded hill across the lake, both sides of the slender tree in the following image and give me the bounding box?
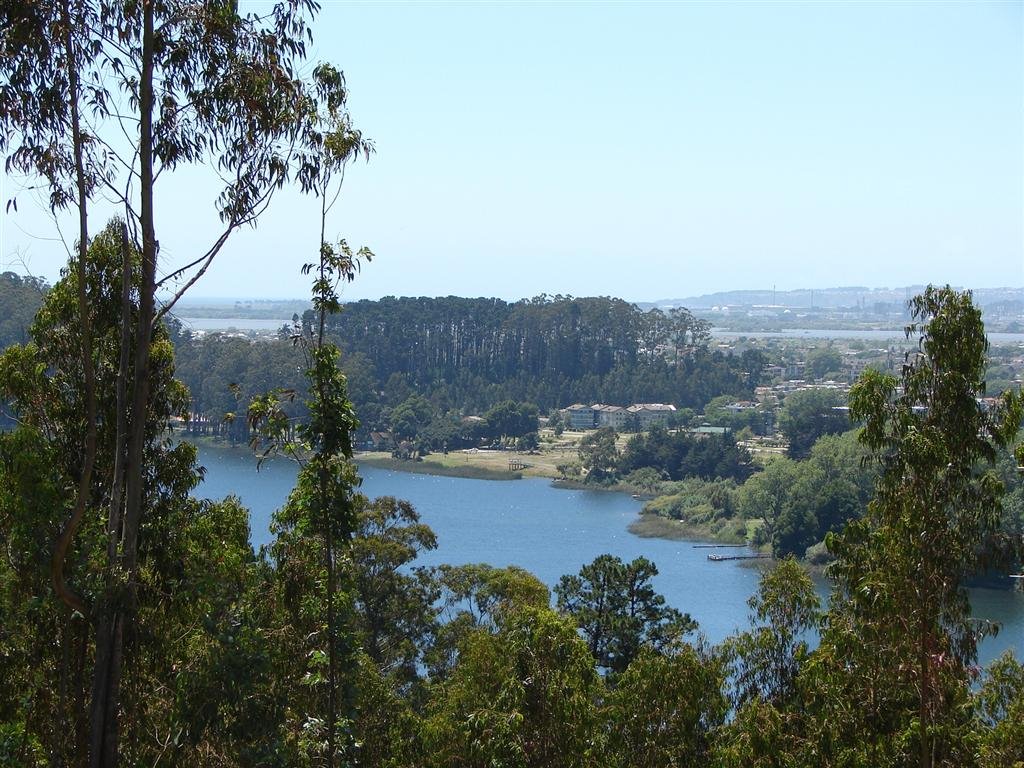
[163,297,765,450]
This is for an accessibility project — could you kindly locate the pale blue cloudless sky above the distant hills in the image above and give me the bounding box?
[0,0,1024,301]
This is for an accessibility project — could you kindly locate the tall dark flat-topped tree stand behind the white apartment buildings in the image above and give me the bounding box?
[319,296,765,413]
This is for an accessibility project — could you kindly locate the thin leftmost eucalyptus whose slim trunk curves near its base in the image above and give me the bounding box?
[0,0,111,663]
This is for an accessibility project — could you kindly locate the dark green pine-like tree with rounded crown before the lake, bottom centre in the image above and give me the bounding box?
[555,555,697,673]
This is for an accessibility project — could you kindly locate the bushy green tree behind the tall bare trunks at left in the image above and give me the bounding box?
[0,224,260,765]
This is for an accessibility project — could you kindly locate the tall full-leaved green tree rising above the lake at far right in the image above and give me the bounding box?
[823,287,1022,768]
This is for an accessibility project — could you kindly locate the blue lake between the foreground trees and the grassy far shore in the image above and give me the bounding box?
[197,446,1024,664]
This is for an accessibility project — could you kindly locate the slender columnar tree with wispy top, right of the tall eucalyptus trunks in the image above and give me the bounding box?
[249,65,373,768]
